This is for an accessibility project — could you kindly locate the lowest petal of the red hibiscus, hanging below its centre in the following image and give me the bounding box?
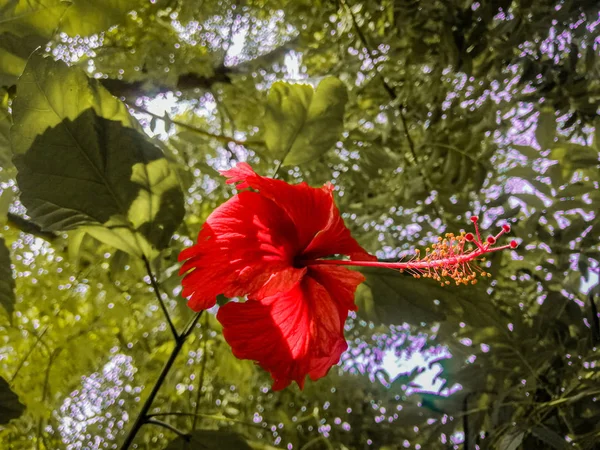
[217,277,348,390]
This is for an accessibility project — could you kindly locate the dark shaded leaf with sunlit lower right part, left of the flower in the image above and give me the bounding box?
[14,110,184,257]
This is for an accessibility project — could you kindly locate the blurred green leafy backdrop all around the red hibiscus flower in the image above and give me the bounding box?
[0,0,600,450]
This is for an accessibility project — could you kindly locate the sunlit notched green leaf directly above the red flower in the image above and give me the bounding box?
[264,77,348,165]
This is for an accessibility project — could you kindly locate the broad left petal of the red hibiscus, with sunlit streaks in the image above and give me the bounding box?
[179,192,306,311]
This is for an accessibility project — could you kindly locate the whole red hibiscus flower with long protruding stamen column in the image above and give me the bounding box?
[179,163,517,390]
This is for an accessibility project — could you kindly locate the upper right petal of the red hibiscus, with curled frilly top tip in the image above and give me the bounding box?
[221,163,377,261]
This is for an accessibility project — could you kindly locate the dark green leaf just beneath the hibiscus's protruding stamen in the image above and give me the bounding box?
[356,268,445,325]
